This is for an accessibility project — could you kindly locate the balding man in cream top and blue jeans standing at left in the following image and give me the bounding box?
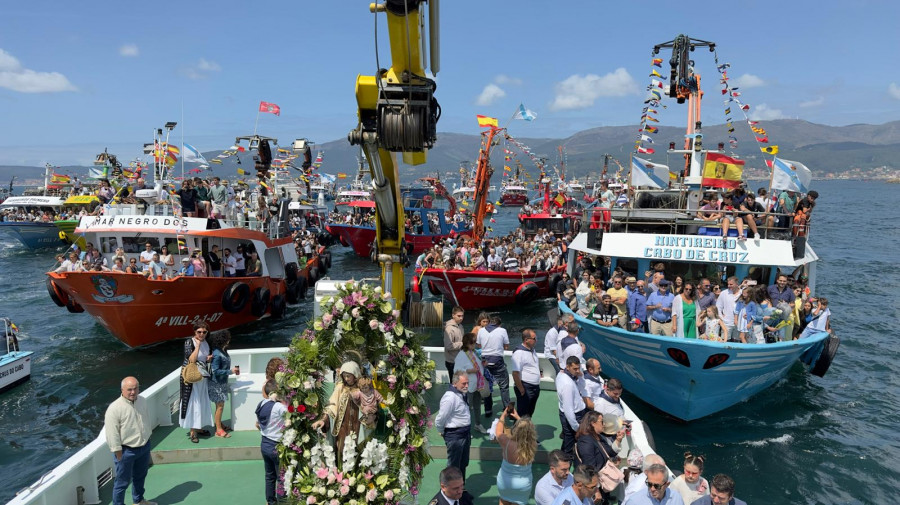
[104,377,156,505]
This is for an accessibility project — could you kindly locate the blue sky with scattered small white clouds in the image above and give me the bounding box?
[0,0,900,166]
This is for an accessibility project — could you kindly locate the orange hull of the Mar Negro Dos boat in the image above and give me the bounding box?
[48,271,288,347]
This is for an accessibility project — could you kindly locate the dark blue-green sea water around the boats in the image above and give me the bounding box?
[0,182,900,504]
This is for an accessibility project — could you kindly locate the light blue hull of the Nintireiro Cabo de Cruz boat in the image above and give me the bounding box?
[560,304,829,421]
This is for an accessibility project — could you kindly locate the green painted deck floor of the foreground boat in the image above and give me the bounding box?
[100,385,561,505]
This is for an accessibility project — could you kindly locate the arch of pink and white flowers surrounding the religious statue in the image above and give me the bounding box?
[275,281,434,505]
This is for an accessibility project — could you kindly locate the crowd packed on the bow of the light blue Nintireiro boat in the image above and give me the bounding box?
[556,255,831,344]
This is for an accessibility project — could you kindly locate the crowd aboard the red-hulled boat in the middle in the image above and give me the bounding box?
[416,228,571,273]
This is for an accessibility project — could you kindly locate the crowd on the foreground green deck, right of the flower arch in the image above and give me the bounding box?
[440,307,744,505]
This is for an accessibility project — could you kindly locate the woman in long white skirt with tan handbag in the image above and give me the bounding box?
[179,321,213,444]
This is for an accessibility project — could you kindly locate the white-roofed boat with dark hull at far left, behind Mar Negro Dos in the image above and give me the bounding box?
[0,196,65,249]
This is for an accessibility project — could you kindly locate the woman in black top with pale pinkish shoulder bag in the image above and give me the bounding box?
[575,410,625,503]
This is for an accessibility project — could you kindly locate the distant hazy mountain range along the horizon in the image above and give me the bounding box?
[7,119,900,184]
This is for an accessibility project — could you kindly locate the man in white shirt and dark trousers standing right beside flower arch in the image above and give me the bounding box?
[434,370,472,482]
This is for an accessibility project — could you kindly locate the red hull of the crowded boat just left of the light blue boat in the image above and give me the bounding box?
[416,266,566,310]
